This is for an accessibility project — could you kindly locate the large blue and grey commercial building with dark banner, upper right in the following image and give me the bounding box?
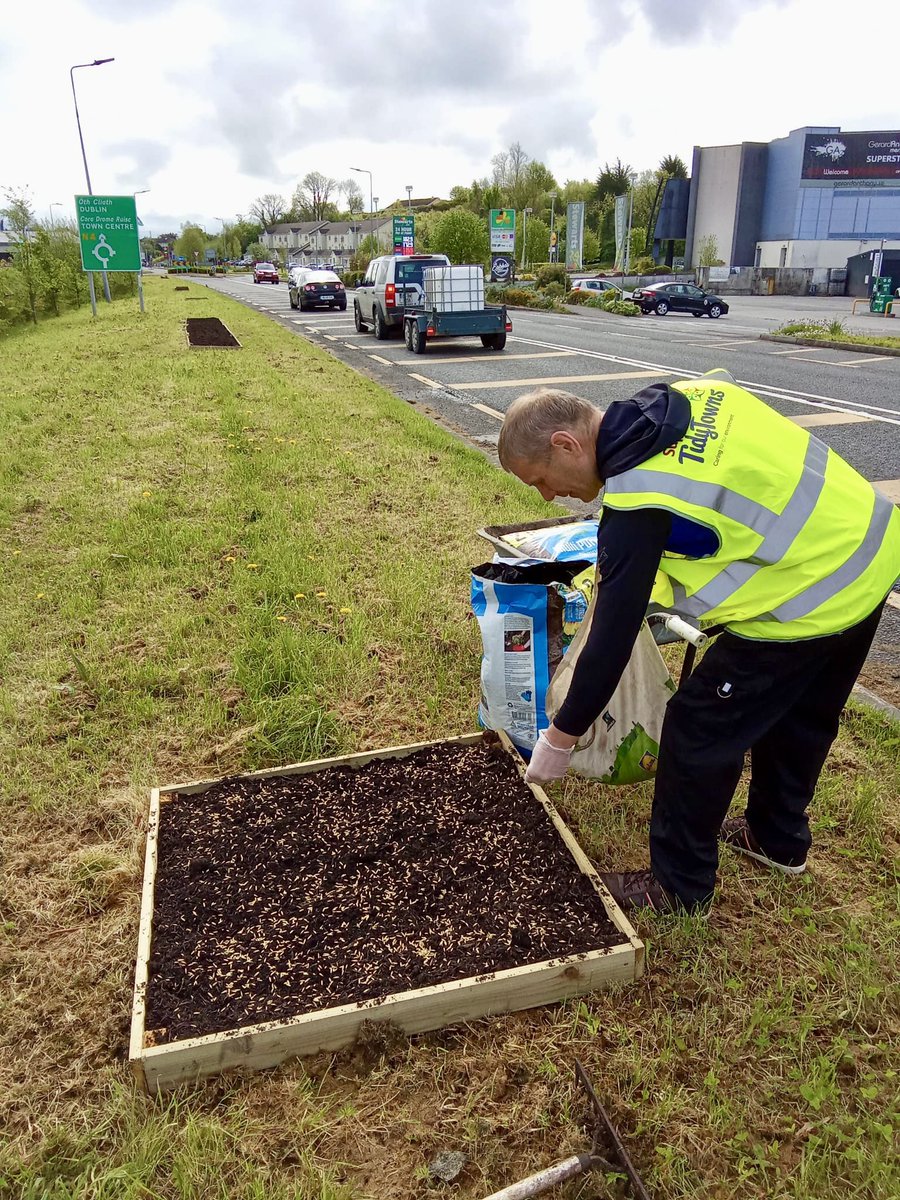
[681,125,900,269]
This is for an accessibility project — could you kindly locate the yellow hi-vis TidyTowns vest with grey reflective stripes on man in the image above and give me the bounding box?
[604,379,900,641]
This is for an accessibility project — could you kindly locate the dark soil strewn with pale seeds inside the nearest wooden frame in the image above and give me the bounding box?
[146,743,624,1043]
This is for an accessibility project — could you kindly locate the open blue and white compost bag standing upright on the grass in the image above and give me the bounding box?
[472,559,596,757]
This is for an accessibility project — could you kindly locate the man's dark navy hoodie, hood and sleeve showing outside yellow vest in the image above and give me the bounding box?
[553,383,696,737]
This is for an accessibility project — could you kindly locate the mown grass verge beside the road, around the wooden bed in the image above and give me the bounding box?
[0,281,900,1200]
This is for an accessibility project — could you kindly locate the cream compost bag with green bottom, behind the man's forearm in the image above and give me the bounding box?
[545,584,676,784]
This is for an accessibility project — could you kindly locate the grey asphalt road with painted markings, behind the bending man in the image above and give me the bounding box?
[199,276,900,704]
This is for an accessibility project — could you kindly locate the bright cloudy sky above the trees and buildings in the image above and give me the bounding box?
[0,0,900,232]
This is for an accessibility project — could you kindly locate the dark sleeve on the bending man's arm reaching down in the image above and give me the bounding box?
[553,509,672,737]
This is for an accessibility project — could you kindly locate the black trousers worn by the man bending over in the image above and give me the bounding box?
[650,605,882,907]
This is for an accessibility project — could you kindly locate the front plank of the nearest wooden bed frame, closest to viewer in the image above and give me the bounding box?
[142,944,636,1092]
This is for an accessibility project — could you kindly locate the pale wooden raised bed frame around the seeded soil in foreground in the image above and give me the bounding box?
[128,733,644,1093]
